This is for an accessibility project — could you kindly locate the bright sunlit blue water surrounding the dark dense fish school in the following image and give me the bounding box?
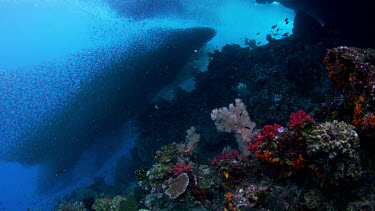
[0,0,294,210]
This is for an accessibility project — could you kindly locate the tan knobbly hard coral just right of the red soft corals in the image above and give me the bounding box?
[307,120,362,184]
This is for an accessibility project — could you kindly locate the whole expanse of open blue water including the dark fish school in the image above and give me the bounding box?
[0,0,295,210]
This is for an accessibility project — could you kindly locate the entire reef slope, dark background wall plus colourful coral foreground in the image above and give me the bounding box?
[56,35,375,210]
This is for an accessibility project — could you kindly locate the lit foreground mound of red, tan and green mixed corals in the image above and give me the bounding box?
[131,92,370,210]
